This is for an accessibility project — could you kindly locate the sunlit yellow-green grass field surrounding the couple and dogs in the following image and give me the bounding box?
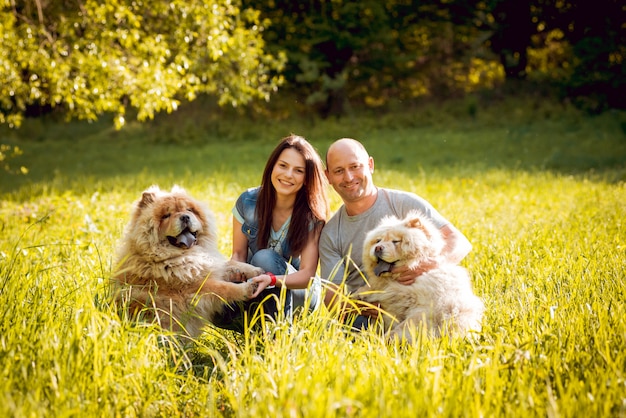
[0,99,626,417]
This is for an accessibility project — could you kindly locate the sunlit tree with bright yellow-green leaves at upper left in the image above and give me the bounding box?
[0,0,285,127]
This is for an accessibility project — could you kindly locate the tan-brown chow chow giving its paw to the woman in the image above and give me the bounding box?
[113,186,263,337]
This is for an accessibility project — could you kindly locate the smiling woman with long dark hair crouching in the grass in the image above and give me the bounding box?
[218,135,330,331]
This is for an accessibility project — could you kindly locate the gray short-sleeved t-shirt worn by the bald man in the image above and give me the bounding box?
[319,188,450,292]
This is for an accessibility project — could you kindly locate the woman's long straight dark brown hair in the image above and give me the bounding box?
[256,134,330,256]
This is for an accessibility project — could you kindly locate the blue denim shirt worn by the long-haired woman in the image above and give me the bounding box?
[233,187,300,269]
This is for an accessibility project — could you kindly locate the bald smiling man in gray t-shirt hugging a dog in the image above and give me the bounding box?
[319,138,472,327]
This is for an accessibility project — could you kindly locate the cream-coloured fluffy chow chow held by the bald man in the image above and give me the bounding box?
[357,211,485,342]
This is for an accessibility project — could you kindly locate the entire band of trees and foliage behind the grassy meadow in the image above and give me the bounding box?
[0,0,626,125]
